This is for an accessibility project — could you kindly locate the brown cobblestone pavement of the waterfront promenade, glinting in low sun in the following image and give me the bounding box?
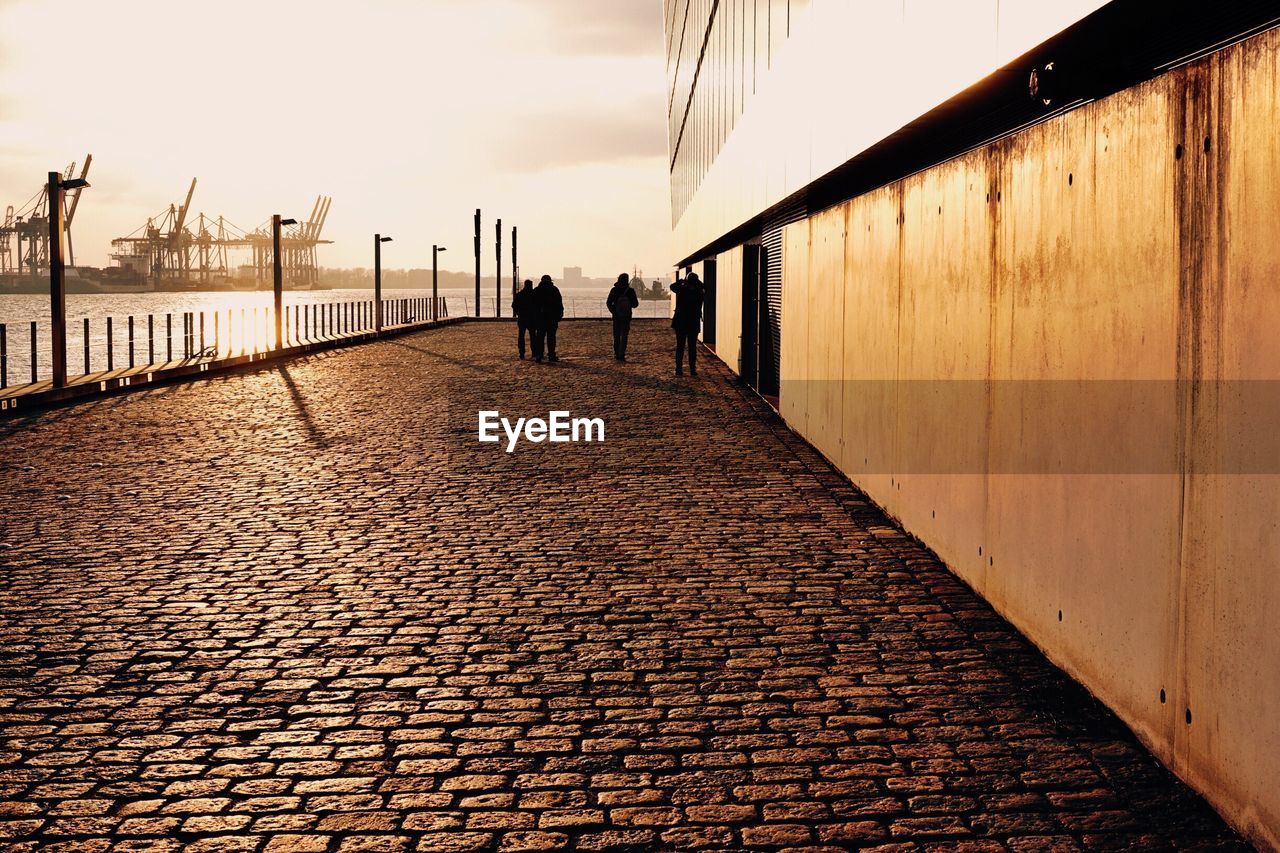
[0,323,1239,853]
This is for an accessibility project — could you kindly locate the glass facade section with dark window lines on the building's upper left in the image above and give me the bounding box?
[663,0,809,223]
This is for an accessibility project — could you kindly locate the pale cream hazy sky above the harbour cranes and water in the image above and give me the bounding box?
[0,0,671,277]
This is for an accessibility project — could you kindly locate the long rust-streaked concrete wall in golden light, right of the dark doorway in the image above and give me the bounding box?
[768,32,1280,848]
